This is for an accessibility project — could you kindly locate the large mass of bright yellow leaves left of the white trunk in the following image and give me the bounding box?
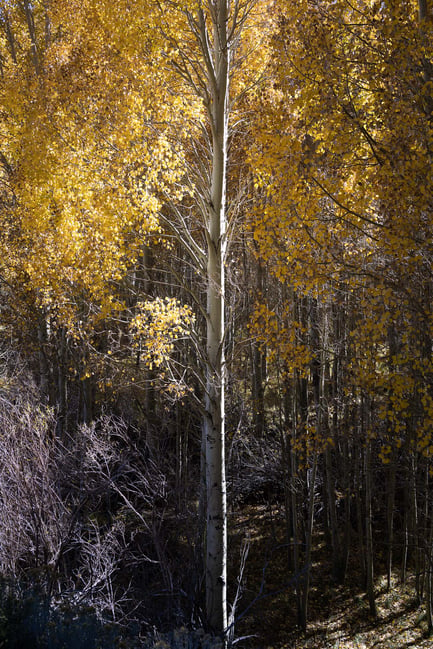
[0,0,194,319]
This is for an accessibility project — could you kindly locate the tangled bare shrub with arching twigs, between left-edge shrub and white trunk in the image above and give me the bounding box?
[63,417,172,621]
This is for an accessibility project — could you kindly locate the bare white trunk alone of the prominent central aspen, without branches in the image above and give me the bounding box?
[199,0,230,634]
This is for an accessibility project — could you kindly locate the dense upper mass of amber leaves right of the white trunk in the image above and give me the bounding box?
[250,0,433,290]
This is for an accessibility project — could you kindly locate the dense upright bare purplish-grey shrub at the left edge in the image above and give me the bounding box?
[0,393,66,578]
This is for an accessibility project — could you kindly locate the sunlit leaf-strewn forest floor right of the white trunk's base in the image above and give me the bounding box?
[231,506,433,649]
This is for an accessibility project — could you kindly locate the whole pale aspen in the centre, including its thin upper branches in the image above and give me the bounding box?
[154,0,267,635]
